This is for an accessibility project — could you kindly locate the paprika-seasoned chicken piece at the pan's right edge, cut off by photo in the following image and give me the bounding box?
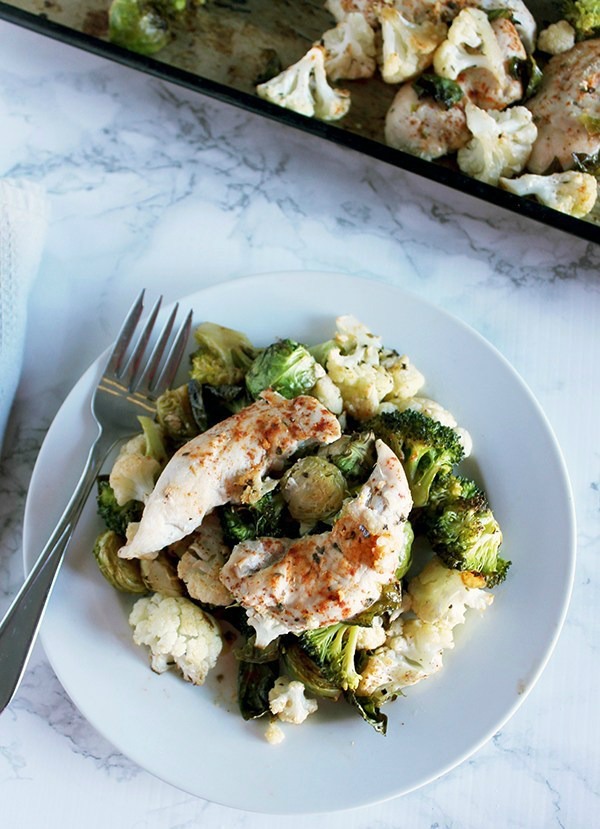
[526,38,600,175]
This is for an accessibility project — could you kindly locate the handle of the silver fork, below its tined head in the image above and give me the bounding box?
[0,426,113,713]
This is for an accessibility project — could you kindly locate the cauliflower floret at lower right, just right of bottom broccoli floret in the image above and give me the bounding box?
[357,618,454,704]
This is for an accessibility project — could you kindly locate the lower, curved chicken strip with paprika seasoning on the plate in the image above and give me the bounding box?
[220,440,412,647]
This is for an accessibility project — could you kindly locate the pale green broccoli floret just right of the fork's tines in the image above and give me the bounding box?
[190,322,258,386]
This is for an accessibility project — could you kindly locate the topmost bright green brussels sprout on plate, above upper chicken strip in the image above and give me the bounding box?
[246,340,318,399]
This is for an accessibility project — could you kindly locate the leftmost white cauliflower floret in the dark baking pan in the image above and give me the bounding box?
[256,46,350,121]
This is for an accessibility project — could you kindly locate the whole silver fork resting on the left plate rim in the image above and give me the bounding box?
[0,291,192,712]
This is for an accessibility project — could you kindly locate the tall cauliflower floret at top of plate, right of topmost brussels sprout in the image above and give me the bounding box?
[327,316,394,420]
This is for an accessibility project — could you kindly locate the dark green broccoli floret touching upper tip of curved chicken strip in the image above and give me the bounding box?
[368,409,463,507]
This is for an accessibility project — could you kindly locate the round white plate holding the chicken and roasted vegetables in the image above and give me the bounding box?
[24,273,575,814]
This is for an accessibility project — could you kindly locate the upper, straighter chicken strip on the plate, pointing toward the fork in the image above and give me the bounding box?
[119,391,341,558]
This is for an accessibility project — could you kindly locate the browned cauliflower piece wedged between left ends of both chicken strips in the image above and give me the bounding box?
[177,513,233,607]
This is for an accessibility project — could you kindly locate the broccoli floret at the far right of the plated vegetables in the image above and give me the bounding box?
[426,490,510,587]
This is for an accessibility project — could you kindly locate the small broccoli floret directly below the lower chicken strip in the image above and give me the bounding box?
[298,622,360,691]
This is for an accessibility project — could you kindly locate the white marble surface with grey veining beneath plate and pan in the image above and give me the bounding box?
[0,17,600,829]
